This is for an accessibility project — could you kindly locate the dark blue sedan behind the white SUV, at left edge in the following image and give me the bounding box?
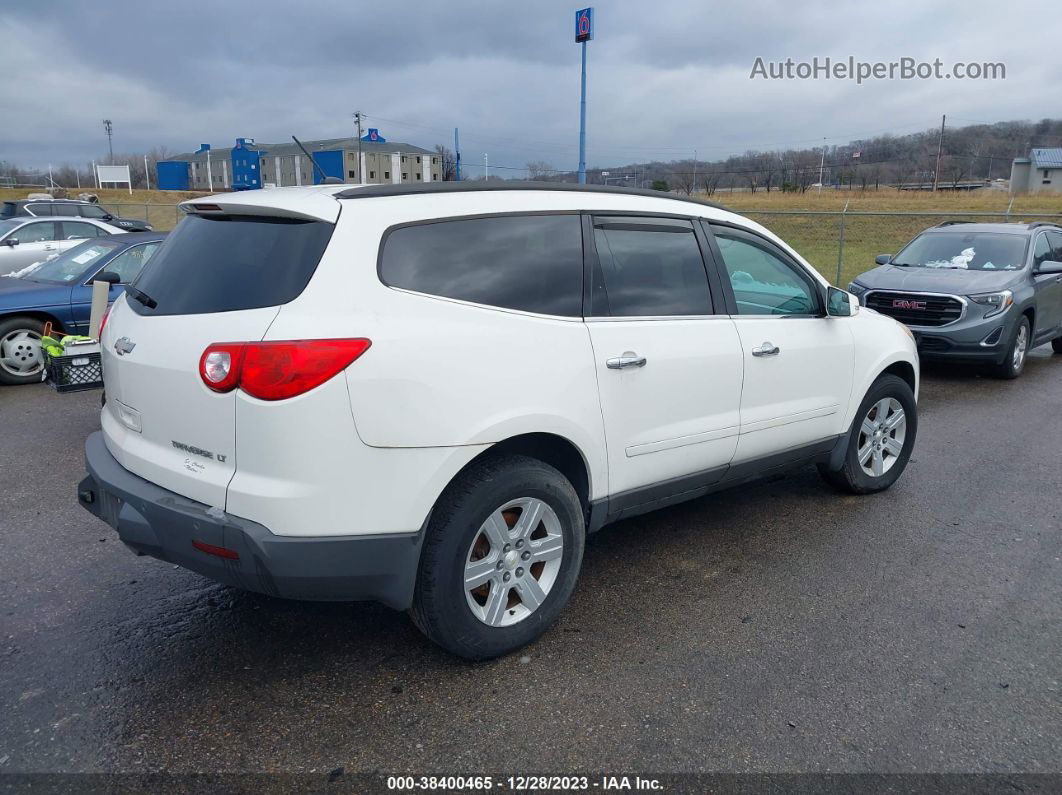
[0,231,166,384]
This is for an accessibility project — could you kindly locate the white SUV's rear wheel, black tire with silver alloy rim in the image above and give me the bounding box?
[410,455,585,660]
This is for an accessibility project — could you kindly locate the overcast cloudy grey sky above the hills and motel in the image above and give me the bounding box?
[0,0,1062,174]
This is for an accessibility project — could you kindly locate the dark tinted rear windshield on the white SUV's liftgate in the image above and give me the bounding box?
[130,215,335,315]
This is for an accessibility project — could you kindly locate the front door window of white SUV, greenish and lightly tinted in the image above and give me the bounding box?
[713,227,819,315]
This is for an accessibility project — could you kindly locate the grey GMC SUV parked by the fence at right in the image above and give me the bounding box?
[849,221,1062,378]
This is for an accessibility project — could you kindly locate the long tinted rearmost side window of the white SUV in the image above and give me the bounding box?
[380,215,583,317]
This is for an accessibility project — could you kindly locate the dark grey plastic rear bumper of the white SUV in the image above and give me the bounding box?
[78,431,424,610]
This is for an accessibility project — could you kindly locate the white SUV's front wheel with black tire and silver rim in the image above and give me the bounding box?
[819,375,919,495]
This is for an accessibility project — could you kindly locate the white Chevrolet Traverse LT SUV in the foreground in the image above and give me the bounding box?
[79,183,918,658]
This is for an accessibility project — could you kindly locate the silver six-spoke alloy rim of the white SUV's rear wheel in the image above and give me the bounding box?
[464,497,564,626]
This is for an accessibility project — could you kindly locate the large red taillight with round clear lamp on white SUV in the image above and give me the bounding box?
[200,338,373,400]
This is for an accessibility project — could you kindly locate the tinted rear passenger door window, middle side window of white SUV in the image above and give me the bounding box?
[592,218,712,317]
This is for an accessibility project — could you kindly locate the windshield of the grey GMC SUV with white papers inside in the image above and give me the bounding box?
[890,231,1028,271]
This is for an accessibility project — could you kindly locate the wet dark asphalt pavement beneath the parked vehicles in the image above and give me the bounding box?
[0,347,1062,776]
